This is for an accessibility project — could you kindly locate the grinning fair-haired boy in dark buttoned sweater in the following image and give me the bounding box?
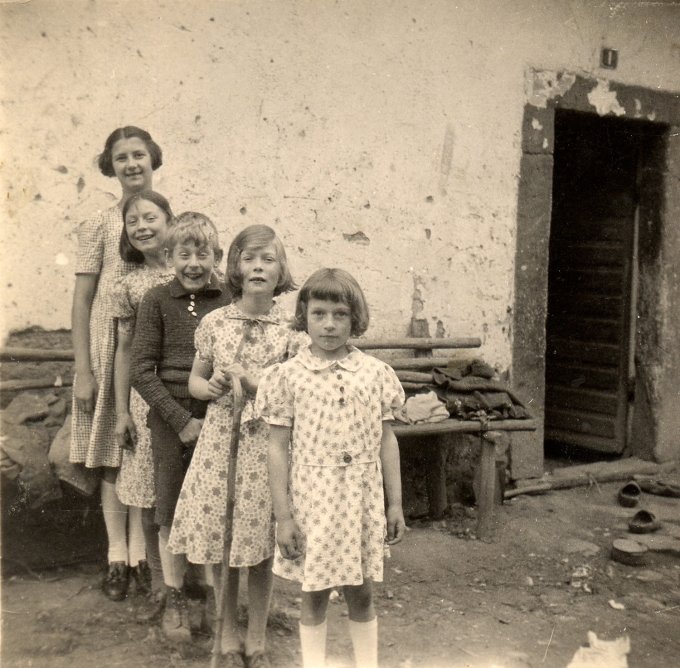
[130,211,231,641]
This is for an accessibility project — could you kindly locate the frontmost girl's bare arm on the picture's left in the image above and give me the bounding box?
[267,425,302,559]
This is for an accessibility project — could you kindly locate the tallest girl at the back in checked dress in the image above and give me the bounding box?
[69,125,163,600]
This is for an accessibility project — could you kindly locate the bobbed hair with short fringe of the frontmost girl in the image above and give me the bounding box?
[293,268,369,336]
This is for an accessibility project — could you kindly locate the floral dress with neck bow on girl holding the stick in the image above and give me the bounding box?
[168,302,309,567]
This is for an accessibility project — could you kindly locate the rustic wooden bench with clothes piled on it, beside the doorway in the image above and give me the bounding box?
[351,337,537,540]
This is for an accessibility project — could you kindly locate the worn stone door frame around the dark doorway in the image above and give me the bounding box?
[510,69,680,479]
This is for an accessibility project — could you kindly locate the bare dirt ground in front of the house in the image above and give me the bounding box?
[2,476,680,668]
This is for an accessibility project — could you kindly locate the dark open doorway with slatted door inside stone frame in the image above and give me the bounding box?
[545,110,657,454]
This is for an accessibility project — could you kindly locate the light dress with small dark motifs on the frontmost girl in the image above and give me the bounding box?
[255,347,404,591]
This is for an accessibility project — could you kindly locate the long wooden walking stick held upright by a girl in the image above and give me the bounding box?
[210,373,243,668]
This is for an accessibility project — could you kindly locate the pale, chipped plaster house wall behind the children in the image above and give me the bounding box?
[0,0,680,368]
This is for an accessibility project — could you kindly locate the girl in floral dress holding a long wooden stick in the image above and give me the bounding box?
[168,225,307,668]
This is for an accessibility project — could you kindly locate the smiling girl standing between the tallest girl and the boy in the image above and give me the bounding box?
[111,190,175,595]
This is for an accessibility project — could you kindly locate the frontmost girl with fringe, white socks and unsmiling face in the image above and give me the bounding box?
[256,269,405,668]
